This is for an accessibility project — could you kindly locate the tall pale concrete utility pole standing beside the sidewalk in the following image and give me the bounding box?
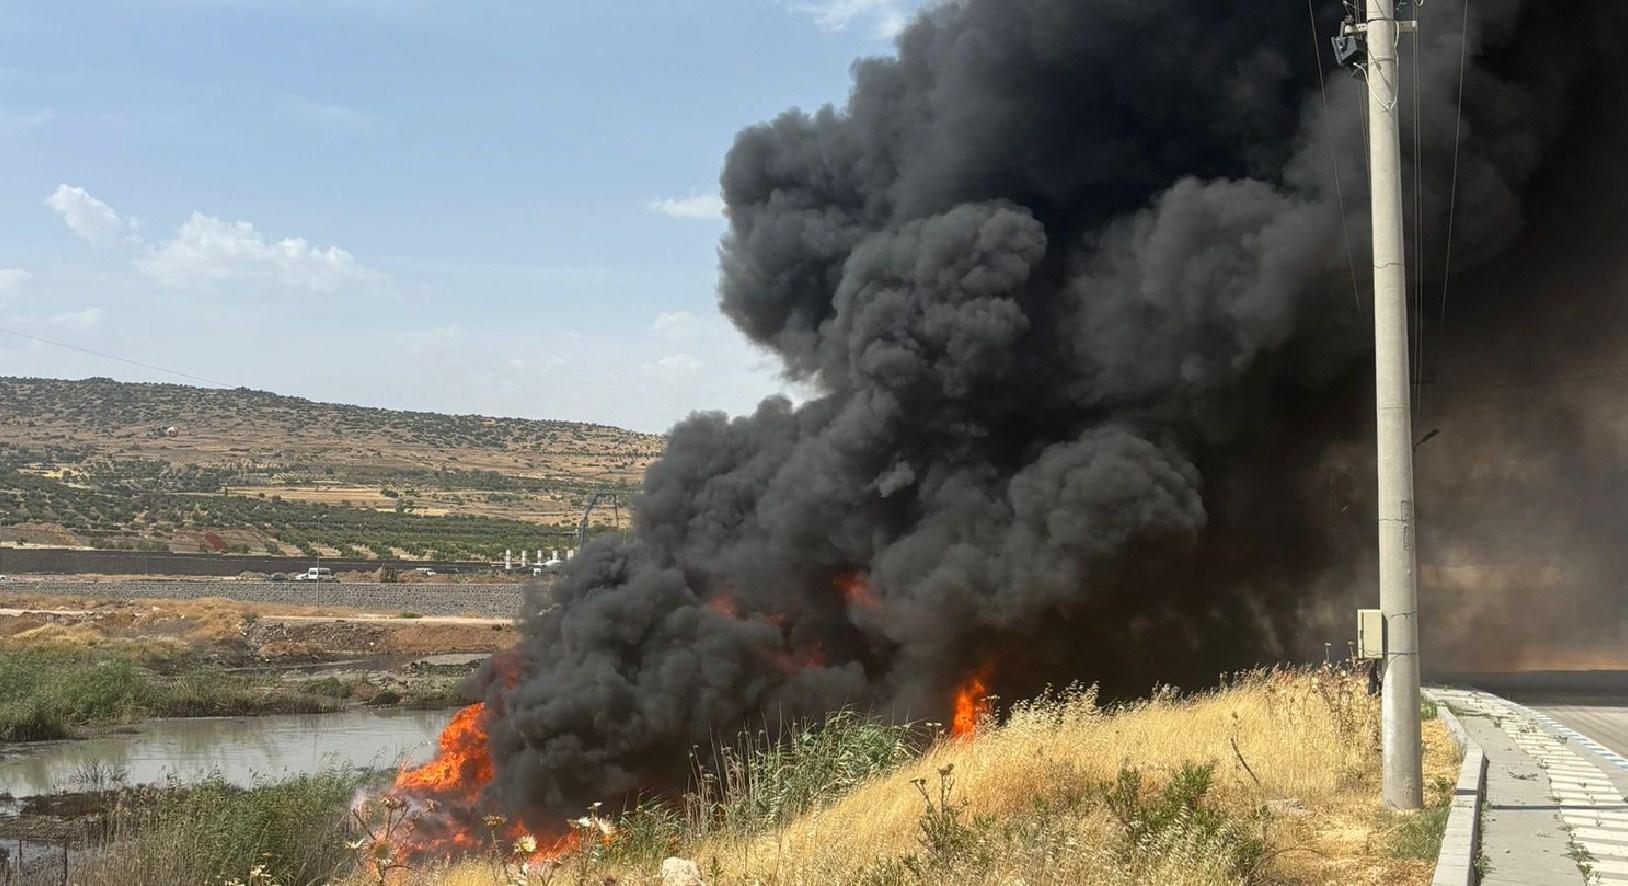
[1366,0,1425,809]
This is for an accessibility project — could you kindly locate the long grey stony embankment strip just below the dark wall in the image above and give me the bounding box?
[0,580,524,619]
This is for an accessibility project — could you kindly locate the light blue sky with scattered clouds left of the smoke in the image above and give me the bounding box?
[0,0,920,430]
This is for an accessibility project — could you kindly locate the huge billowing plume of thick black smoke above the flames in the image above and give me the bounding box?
[485,0,1628,816]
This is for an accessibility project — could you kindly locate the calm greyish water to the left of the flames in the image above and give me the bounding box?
[0,710,451,798]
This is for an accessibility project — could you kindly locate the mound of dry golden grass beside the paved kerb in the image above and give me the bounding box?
[366,671,1457,886]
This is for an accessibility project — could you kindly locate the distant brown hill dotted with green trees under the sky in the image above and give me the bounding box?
[0,378,664,557]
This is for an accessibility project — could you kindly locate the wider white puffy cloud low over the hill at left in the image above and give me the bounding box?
[135,212,383,292]
